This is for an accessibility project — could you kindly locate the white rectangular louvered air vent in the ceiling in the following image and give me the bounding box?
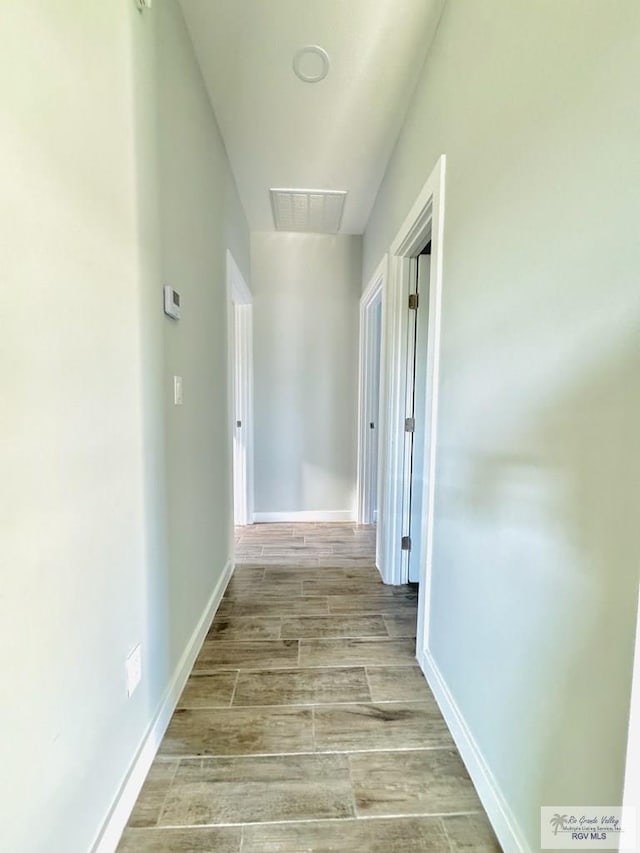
[269,189,347,234]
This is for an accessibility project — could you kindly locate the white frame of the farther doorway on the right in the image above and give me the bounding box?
[356,255,387,536]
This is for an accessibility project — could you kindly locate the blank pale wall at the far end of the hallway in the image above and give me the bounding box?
[251,232,362,513]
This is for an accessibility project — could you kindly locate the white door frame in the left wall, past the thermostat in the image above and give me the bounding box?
[227,249,254,525]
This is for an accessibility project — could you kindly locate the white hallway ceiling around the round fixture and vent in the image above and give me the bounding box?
[181,0,444,234]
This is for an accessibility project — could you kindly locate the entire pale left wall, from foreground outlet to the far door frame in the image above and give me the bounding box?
[0,0,249,853]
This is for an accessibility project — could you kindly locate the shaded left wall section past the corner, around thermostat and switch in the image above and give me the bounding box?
[157,2,250,655]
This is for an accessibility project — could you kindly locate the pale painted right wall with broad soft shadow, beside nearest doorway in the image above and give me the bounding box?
[363,0,640,851]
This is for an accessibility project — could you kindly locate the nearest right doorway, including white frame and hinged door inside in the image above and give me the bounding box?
[378,155,446,664]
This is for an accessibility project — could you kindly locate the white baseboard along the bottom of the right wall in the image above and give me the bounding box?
[418,652,533,853]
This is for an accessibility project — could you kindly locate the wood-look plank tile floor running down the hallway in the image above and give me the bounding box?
[118,524,500,853]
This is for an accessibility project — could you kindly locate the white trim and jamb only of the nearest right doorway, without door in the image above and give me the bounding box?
[381,154,446,648]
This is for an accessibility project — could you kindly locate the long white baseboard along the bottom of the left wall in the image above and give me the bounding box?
[91,560,233,853]
